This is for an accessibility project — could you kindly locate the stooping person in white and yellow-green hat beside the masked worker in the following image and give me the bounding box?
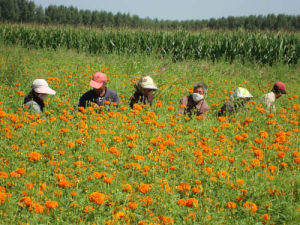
[218,87,253,117]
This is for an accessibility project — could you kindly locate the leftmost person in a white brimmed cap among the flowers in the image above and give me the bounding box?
[24,79,56,113]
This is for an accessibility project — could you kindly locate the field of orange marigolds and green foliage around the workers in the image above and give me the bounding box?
[0,44,300,225]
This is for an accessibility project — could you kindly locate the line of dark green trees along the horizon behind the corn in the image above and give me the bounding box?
[0,0,300,31]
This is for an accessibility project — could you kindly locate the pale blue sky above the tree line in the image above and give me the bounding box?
[33,0,300,20]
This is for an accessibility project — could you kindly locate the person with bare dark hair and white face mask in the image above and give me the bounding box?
[179,82,209,117]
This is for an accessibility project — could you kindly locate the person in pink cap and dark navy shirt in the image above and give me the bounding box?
[78,72,119,108]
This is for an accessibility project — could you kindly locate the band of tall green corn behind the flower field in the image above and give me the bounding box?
[0,24,300,65]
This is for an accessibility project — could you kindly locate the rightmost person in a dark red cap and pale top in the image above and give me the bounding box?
[261,81,286,112]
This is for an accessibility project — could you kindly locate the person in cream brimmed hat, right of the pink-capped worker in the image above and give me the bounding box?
[129,76,158,108]
